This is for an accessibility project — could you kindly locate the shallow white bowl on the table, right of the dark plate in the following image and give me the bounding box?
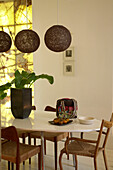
[78,116,95,125]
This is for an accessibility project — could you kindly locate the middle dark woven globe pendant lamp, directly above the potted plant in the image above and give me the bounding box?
[15,29,40,53]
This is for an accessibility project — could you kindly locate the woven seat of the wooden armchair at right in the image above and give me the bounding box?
[62,141,101,157]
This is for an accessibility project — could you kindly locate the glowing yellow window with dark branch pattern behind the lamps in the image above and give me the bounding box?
[0,0,33,111]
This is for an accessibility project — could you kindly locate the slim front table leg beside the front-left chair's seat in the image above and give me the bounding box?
[41,132,45,170]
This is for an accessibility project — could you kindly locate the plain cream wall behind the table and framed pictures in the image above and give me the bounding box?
[33,0,113,119]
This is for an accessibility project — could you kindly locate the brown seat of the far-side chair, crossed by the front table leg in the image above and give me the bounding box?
[30,132,68,142]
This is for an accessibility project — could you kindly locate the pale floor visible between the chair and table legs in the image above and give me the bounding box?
[1,132,113,170]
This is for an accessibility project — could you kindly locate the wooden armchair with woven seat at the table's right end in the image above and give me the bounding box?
[59,114,113,170]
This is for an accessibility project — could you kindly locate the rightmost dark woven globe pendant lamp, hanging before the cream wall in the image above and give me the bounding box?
[44,25,71,52]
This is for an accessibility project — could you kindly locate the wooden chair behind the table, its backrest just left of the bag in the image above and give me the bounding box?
[29,106,69,170]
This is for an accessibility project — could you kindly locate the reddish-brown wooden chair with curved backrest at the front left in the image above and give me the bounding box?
[1,126,41,170]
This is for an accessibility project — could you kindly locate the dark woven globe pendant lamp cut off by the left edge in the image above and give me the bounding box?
[0,31,12,52]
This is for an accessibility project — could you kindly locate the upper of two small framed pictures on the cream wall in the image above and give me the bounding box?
[64,47,75,60]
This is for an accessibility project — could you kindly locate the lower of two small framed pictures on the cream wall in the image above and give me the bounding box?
[63,61,75,76]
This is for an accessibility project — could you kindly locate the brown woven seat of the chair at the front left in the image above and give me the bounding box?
[2,141,41,163]
